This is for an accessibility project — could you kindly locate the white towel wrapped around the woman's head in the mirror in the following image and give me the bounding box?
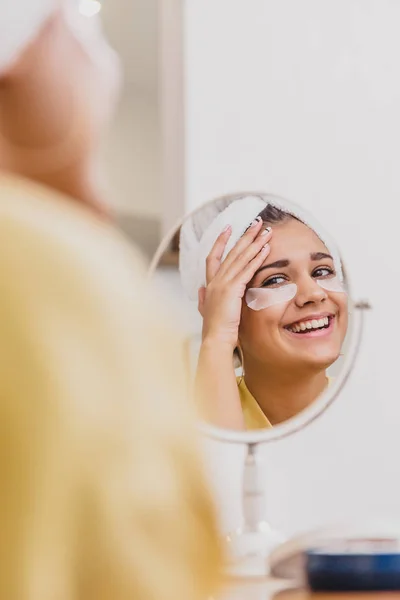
[179,194,343,301]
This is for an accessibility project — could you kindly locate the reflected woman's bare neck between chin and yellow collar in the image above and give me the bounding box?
[244,364,328,425]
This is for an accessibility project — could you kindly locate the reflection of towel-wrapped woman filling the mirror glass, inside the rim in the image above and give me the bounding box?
[153,194,349,430]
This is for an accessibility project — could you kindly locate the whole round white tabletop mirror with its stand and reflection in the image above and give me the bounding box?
[150,193,368,577]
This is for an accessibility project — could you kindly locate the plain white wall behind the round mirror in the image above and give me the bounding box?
[185,0,400,533]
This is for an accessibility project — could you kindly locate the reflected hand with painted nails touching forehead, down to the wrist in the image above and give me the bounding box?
[199,217,272,352]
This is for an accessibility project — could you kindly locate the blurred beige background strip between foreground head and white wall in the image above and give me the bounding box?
[99,0,176,257]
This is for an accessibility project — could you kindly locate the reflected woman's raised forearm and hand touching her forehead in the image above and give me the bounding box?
[196,218,272,431]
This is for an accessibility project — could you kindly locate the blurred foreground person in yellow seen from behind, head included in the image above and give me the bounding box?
[0,0,221,600]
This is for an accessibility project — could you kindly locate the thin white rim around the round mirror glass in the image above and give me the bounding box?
[148,191,371,445]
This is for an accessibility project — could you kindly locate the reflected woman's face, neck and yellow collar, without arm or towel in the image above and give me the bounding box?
[238,206,348,428]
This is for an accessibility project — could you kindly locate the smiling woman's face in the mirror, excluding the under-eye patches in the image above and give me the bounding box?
[239,219,348,370]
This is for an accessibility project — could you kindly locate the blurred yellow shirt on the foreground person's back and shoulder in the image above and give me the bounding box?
[0,175,223,600]
